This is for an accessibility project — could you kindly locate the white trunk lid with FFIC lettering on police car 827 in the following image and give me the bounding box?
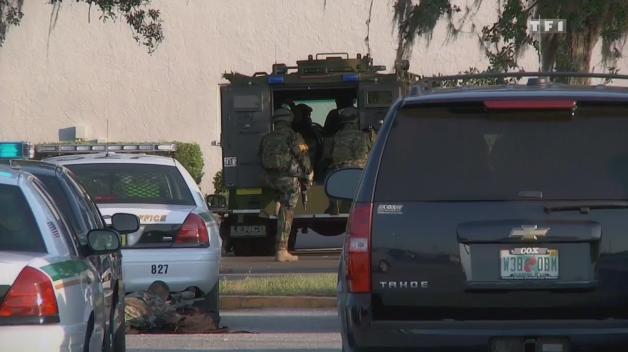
[98,203,195,225]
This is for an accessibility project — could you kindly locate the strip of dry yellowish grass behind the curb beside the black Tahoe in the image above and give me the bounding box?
[220,274,338,297]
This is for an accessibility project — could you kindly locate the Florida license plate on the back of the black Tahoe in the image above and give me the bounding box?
[500,247,559,280]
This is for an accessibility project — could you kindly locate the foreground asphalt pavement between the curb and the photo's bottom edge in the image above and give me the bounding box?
[127,310,340,352]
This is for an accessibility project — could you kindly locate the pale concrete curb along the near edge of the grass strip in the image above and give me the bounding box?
[220,296,336,310]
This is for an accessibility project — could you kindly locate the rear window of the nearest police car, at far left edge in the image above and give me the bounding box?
[0,185,46,253]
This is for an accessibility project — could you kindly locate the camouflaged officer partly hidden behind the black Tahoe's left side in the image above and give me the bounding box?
[326,107,373,214]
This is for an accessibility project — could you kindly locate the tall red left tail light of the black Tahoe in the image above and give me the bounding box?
[346,203,373,293]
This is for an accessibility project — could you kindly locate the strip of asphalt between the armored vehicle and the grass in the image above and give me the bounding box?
[220,251,340,277]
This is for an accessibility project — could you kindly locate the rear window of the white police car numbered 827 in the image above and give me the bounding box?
[66,163,194,205]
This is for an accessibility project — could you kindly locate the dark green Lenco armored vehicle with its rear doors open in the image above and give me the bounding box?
[213,53,414,255]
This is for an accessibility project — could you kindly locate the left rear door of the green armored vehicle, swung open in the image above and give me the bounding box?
[220,85,271,188]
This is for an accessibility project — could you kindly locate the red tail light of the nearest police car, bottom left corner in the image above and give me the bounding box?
[0,266,59,318]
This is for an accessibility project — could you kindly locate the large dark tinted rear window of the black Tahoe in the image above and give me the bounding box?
[375,103,628,201]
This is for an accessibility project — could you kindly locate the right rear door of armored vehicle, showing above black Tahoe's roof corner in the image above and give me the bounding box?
[358,79,401,130]
